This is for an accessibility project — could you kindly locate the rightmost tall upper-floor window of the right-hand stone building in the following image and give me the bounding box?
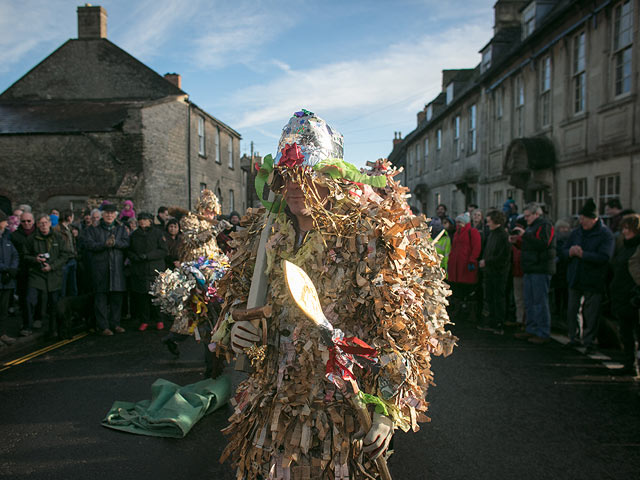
[613,0,633,96]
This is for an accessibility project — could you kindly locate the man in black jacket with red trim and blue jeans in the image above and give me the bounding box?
[515,203,556,344]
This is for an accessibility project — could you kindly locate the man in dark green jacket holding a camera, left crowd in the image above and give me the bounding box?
[20,213,70,337]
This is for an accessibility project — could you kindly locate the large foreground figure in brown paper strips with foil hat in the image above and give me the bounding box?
[213,110,456,479]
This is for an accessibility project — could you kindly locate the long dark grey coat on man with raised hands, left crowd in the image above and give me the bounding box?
[82,220,129,293]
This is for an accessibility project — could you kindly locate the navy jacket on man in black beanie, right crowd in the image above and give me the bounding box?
[562,219,615,293]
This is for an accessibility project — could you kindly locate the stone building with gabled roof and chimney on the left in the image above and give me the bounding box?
[0,6,246,213]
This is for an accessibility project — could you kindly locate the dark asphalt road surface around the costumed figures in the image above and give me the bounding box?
[0,318,640,480]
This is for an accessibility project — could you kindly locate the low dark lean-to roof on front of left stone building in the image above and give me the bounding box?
[0,102,133,134]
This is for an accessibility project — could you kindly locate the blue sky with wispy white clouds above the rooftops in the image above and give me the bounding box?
[0,0,495,166]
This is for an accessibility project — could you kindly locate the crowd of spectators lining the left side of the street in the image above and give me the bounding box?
[0,200,240,348]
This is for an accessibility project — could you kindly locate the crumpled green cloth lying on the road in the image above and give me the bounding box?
[102,376,231,438]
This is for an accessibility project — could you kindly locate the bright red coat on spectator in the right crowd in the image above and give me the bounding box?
[448,223,482,283]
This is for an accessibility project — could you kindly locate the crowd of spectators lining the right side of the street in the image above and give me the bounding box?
[431,198,640,374]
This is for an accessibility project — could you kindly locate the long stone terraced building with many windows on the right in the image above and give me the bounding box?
[389,0,640,218]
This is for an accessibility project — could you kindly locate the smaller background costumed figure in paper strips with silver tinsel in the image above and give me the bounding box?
[150,189,229,376]
